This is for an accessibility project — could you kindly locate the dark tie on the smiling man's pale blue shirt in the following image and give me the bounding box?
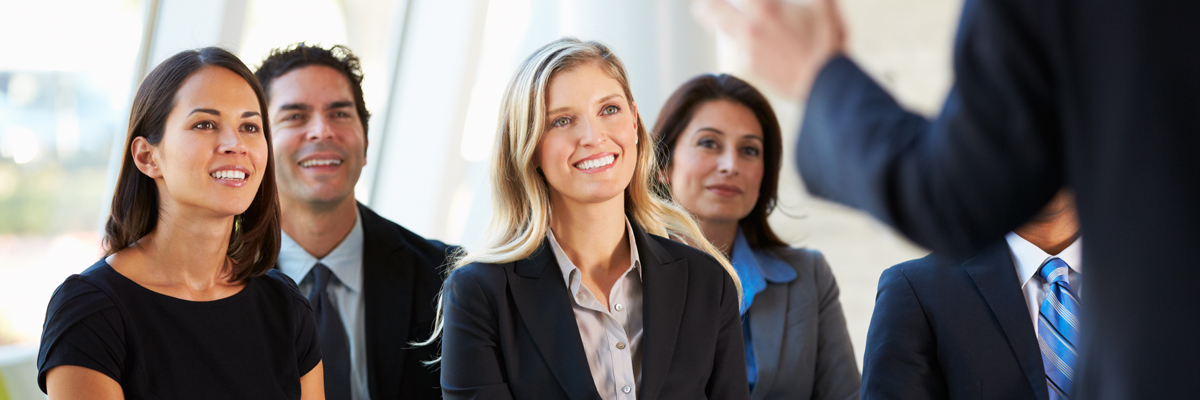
[308,263,350,400]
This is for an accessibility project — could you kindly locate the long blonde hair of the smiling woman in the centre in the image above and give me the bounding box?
[418,37,742,353]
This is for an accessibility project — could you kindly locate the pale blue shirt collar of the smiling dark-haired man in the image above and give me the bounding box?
[278,206,362,292]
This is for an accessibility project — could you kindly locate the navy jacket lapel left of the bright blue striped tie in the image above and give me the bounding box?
[962,241,1049,400]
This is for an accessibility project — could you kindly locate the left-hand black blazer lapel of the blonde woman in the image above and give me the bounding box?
[509,241,600,400]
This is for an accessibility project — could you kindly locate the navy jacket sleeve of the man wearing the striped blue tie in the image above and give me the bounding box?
[862,267,947,400]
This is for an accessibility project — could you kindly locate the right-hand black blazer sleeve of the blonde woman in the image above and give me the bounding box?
[704,269,750,400]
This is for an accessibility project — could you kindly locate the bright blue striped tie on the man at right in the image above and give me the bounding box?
[1038,258,1079,400]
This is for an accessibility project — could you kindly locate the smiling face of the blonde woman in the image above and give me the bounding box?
[535,62,637,203]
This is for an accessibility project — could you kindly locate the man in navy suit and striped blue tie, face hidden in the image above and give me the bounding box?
[862,191,1082,400]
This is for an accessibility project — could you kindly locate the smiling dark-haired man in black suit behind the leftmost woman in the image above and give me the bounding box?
[254,43,449,400]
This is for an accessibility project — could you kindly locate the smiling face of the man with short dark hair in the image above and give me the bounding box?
[269,65,367,207]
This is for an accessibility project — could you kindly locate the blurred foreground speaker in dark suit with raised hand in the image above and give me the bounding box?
[697,0,1200,399]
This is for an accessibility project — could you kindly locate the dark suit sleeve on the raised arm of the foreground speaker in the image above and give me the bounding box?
[797,0,1063,255]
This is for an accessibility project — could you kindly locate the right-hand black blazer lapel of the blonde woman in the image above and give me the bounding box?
[630,219,688,399]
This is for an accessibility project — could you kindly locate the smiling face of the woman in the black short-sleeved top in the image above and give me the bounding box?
[141,66,270,215]
